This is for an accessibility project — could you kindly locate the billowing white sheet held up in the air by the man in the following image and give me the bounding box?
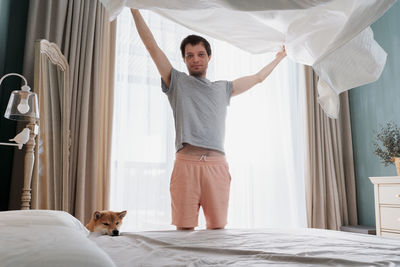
[100,0,396,117]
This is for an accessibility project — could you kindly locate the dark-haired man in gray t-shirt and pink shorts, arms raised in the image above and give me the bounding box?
[131,9,286,230]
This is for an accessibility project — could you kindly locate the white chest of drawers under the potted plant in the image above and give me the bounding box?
[369,176,400,238]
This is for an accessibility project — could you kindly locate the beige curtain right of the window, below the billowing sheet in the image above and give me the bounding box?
[305,66,357,230]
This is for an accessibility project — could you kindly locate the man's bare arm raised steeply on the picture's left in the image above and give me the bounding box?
[131,8,172,87]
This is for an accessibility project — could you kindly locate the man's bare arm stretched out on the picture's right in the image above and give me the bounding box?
[232,46,286,96]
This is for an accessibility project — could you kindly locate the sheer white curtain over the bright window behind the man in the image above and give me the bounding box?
[110,9,306,231]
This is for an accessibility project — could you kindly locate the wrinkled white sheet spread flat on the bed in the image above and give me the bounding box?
[89,229,400,267]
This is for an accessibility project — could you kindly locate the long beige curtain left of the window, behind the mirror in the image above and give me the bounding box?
[9,0,116,223]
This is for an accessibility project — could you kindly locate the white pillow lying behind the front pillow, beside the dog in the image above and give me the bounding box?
[0,210,89,236]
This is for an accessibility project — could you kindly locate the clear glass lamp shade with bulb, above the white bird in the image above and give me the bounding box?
[4,90,39,121]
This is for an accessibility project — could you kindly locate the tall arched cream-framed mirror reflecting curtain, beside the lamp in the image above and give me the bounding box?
[31,39,71,211]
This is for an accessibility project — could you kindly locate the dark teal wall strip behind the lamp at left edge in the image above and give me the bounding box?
[0,0,29,211]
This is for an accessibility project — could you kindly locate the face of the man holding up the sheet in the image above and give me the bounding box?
[183,43,211,78]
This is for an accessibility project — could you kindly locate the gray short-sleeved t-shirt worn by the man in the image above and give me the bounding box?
[161,68,232,153]
